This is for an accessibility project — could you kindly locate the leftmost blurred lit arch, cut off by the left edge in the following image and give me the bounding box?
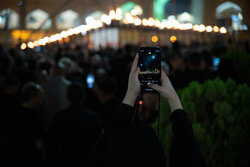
[0,9,20,29]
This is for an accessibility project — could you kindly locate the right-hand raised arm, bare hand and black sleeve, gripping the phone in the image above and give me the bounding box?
[149,72,206,167]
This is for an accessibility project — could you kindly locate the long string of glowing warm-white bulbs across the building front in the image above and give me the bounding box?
[21,7,227,50]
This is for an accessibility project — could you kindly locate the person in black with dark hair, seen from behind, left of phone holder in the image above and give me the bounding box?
[46,83,102,167]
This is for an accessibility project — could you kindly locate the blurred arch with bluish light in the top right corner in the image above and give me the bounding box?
[216,1,243,30]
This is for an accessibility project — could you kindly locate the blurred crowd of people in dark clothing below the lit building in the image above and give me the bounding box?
[0,38,248,166]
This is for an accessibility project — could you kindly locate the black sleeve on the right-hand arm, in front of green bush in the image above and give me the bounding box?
[170,109,206,167]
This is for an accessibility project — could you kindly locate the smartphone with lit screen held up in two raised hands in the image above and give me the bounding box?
[138,47,161,92]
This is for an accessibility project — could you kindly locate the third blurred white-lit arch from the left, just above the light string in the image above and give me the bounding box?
[56,9,81,30]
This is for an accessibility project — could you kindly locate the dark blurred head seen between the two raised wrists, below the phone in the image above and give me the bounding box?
[138,93,159,124]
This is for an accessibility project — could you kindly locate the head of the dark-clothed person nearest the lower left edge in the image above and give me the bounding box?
[21,82,43,109]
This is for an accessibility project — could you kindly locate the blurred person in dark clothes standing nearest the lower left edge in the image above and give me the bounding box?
[4,82,44,167]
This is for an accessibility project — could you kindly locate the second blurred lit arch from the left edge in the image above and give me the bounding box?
[25,9,51,29]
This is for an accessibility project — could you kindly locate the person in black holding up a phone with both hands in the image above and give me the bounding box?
[89,55,206,167]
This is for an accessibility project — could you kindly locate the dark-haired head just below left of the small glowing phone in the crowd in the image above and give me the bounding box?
[67,82,85,105]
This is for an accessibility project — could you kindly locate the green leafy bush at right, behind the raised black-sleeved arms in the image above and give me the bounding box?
[155,78,250,167]
